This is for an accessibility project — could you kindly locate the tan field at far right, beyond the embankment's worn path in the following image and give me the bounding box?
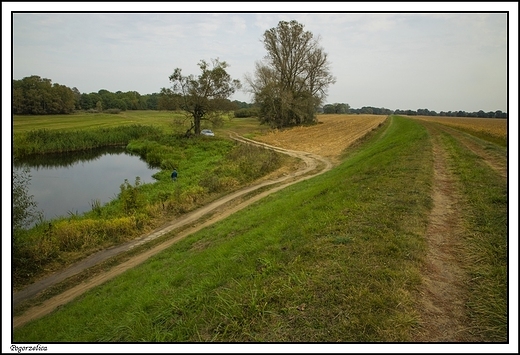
[415,116,507,146]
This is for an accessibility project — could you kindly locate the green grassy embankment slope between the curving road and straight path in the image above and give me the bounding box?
[14,117,432,342]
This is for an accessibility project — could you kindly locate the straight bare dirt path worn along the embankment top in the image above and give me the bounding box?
[414,123,472,342]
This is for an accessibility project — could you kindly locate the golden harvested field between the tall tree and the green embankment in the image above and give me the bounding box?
[255,114,386,162]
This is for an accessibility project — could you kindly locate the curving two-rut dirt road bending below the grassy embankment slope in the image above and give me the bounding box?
[13,133,332,328]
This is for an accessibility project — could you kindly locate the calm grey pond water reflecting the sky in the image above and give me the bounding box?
[14,148,159,224]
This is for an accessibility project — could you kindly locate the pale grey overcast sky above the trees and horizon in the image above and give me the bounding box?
[5,3,518,112]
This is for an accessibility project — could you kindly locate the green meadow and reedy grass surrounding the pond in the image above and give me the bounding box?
[13,111,287,287]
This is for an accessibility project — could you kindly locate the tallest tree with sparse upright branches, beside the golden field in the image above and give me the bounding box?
[246,20,336,127]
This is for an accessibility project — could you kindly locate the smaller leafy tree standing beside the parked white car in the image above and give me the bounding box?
[169,58,241,135]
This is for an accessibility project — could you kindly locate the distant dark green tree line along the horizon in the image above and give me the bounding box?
[13,75,507,118]
